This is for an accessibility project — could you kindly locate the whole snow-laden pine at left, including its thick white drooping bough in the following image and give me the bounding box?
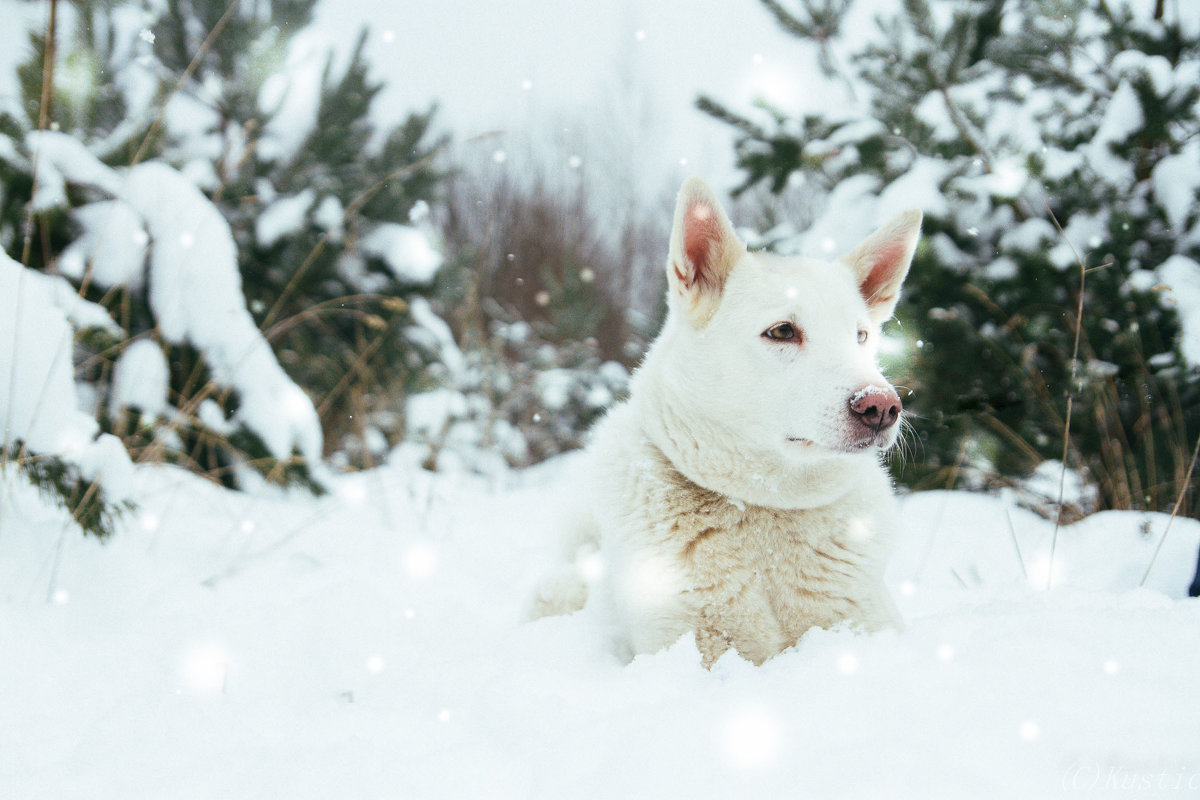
[0,0,451,501]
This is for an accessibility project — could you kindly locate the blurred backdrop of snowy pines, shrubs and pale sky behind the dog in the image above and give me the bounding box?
[0,0,1200,534]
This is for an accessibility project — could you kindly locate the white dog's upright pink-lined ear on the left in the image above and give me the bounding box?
[667,178,746,327]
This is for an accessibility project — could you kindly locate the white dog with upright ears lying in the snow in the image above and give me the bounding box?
[534,179,920,666]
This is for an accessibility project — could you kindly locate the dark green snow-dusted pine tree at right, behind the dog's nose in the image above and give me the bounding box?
[698,0,1200,513]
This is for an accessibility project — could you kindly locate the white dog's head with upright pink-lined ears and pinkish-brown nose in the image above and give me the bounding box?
[655,179,920,491]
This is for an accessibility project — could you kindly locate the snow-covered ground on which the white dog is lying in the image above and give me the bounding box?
[0,458,1200,800]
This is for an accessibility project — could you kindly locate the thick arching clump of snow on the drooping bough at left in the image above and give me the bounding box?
[30,132,323,467]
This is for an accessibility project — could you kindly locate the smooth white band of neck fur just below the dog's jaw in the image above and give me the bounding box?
[631,353,878,509]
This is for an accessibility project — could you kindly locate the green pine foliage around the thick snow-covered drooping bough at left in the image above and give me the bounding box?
[0,0,451,506]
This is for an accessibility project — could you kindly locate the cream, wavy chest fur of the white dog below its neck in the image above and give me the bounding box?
[598,402,894,664]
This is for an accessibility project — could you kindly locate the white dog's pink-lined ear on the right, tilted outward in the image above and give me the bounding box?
[841,209,922,325]
